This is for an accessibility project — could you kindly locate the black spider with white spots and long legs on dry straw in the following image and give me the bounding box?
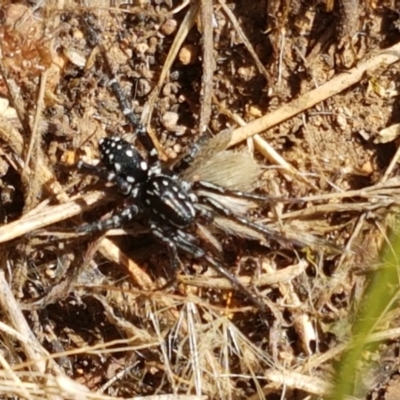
[78,14,334,312]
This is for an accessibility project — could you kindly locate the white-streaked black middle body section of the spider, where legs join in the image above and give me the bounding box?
[144,175,196,228]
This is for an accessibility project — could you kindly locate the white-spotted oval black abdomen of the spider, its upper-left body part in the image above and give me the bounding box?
[99,137,148,184]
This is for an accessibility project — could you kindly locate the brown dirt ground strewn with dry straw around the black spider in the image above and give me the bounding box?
[0,0,400,400]
